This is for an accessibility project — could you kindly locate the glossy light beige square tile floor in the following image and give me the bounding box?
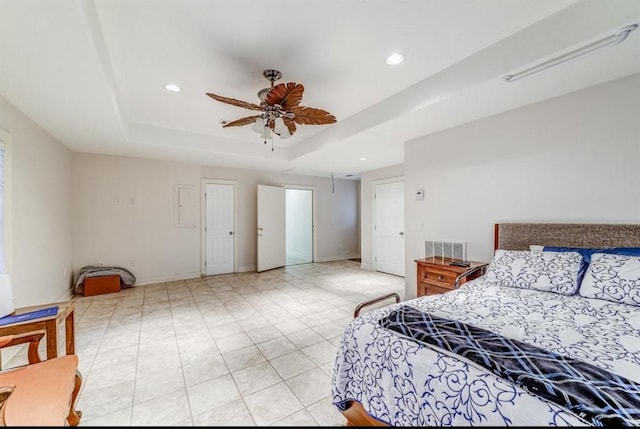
[11,260,404,426]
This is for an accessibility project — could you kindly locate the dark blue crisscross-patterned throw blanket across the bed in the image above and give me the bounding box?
[380,306,640,426]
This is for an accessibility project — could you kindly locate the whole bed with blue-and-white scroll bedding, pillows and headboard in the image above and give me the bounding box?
[332,223,640,426]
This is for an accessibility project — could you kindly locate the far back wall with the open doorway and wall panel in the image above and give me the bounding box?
[73,154,359,284]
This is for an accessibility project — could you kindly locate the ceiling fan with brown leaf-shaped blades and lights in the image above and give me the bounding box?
[207,69,336,146]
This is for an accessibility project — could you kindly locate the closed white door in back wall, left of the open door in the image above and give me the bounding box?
[205,183,234,276]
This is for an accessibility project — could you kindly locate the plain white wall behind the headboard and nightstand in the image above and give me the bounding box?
[404,74,640,298]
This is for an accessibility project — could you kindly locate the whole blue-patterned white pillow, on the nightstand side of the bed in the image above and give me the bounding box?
[485,249,582,295]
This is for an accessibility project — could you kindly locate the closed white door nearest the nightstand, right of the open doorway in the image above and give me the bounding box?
[373,182,404,277]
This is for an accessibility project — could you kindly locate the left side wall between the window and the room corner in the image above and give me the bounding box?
[0,97,72,308]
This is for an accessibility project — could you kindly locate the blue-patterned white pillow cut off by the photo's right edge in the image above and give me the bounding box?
[579,253,640,306]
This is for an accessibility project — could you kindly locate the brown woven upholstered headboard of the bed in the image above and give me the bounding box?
[494,223,640,250]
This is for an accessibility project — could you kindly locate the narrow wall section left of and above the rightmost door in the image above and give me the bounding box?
[360,165,406,270]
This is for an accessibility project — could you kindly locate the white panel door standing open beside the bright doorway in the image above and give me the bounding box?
[258,185,287,272]
